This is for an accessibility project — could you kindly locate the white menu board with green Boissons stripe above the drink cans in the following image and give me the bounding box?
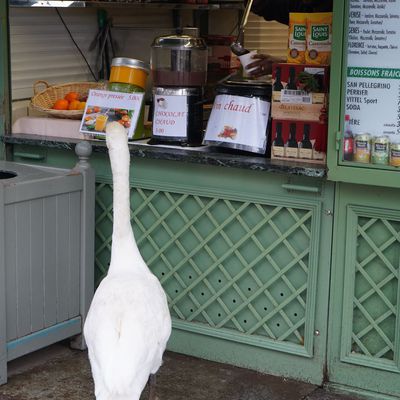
[345,0,400,143]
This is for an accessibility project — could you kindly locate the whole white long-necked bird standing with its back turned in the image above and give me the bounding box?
[84,122,171,400]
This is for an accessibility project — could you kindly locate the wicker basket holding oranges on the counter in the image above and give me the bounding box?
[30,81,104,119]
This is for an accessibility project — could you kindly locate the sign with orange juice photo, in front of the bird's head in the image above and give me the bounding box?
[79,90,144,138]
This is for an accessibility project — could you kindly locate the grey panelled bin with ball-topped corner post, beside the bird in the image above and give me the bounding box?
[0,142,95,384]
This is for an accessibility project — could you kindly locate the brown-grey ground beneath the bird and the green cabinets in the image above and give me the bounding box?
[0,343,355,400]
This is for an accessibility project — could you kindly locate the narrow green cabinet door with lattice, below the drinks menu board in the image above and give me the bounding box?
[329,184,400,399]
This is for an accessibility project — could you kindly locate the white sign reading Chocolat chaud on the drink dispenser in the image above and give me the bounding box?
[153,95,188,137]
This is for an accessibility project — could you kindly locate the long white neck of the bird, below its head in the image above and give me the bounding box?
[109,133,144,272]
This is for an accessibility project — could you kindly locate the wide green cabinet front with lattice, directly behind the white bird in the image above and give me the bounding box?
[96,159,333,384]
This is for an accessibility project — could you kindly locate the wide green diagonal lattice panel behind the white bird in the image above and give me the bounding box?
[96,184,315,347]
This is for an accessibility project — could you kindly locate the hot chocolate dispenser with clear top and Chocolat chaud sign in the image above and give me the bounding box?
[149,34,208,146]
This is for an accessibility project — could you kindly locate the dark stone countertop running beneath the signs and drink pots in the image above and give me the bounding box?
[1,134,326,178]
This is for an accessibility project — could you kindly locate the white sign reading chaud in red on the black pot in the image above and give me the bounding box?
[203,94,270,153]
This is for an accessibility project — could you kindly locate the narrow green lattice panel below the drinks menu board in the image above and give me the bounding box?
[351,216,400,361]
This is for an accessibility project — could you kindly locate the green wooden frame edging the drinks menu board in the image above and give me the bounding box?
[327,0,400,187]
